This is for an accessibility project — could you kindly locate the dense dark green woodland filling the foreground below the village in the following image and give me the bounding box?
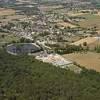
[0,50,100,100]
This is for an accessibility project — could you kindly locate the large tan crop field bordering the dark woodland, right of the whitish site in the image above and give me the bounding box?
[63,52,100,72]
